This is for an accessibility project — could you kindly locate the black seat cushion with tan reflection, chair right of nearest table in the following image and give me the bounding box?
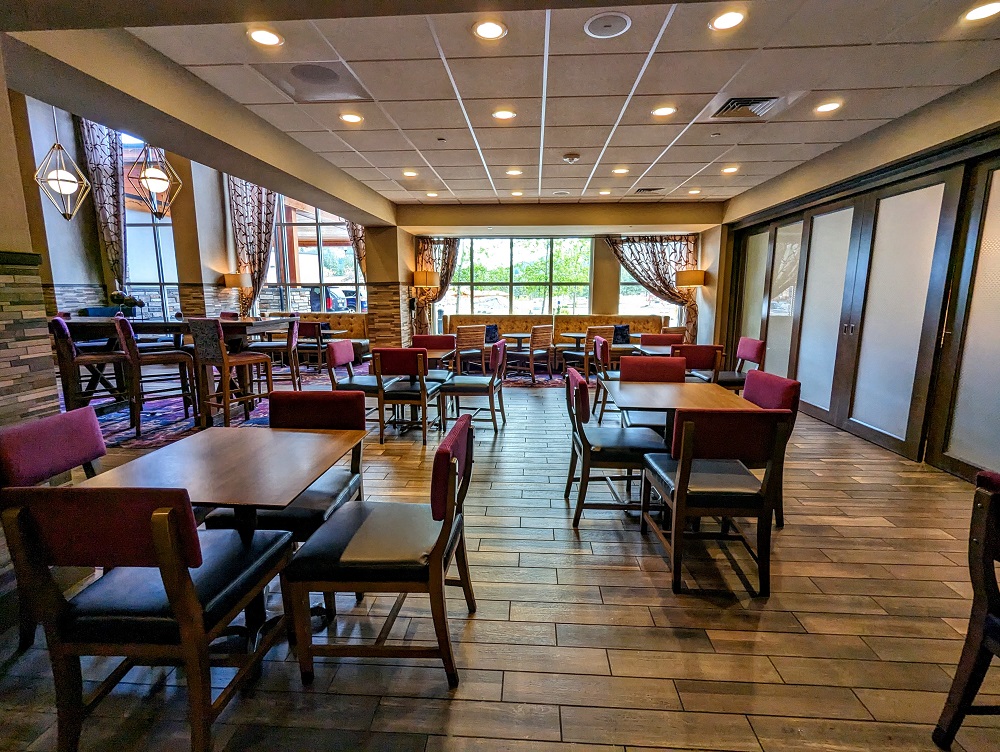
[285,501,441,582]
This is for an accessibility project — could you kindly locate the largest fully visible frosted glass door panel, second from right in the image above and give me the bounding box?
[851,183,944,439]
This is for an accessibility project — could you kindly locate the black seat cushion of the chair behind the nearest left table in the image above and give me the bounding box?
[205,467,361,542]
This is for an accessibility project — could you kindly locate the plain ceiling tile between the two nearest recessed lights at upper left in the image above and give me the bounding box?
[313,16,438,62]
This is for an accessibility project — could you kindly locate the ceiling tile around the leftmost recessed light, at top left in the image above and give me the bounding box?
[128,21,337,65]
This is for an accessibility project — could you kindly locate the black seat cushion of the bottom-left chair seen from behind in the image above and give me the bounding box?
[60,530,292,645]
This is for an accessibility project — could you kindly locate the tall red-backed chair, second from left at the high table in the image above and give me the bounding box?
[115,316,198,439]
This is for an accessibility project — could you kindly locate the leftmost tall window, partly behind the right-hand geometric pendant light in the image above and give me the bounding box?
[122,133,181,320]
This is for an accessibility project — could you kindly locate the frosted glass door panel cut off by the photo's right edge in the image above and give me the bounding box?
[947,171,1000,470]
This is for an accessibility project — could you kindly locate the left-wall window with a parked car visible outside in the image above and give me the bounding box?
[259,196,368,313]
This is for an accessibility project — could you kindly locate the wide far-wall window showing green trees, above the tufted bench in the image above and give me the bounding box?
[438,238,593,314]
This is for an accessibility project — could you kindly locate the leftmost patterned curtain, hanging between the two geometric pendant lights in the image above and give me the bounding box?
[75,118,128,291]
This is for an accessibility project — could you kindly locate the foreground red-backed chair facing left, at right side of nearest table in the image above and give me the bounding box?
[282,414,476,687]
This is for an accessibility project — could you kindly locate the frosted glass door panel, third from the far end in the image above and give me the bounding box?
[795,208,854,410]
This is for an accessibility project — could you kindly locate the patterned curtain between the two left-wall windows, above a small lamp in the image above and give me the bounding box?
[227,175,278,316]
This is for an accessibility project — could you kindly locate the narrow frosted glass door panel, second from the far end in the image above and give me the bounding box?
[764,222,802,376]
